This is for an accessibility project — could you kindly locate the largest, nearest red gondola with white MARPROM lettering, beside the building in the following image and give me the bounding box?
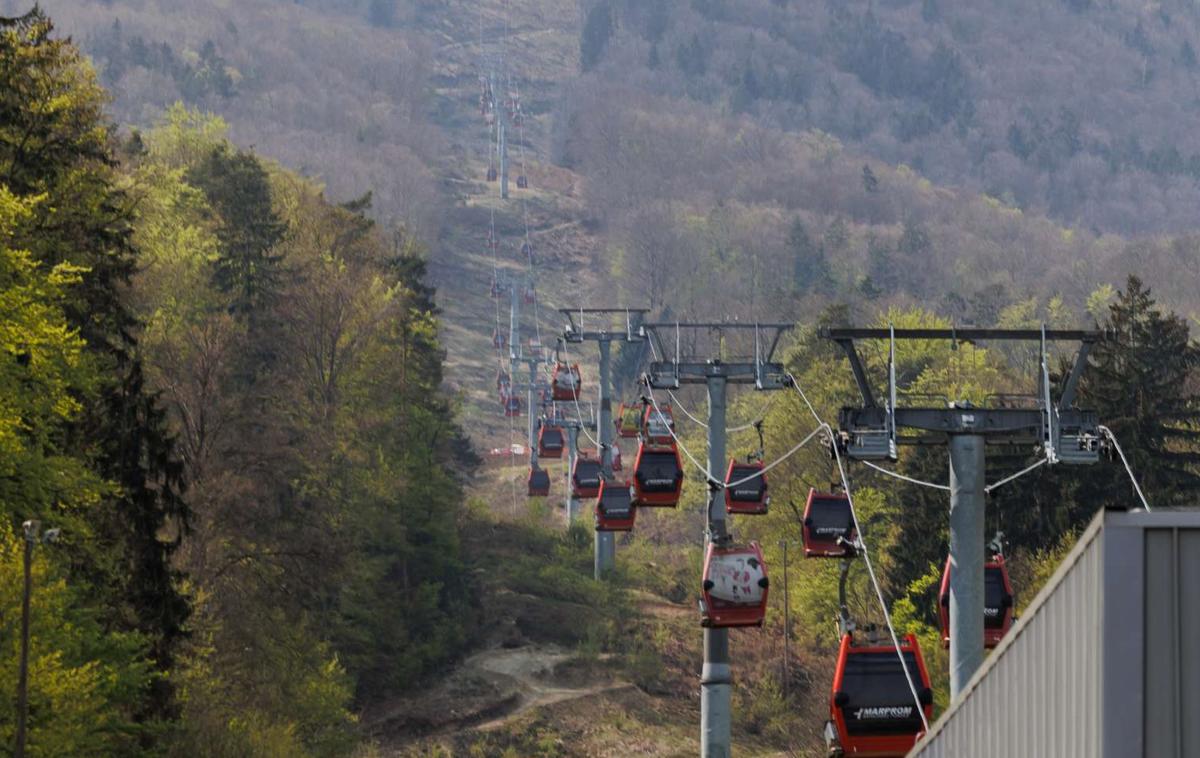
[826,634,934,758]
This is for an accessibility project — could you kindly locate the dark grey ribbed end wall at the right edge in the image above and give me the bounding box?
[1144,528,1200,758]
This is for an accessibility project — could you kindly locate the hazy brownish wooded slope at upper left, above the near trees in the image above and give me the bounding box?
[0,0,445,236]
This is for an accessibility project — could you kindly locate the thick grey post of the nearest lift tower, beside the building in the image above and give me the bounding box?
[949,434,985,699]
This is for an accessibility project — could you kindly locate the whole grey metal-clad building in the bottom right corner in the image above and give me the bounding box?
[910,511,1200,758]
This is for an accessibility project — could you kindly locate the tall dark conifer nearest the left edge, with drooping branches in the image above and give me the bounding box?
[0,8,188,717]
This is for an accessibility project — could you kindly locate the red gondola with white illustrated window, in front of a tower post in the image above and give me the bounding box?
[701,542,769,627]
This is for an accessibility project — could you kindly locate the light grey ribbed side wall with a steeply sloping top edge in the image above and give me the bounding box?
[911,513,1104,758]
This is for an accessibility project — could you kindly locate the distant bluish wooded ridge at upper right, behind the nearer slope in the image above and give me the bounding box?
[583,0,1200,234]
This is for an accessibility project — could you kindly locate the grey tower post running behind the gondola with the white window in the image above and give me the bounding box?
[700,375,733,758]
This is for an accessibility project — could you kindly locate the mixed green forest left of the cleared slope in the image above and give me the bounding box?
[0,11,475,756]
